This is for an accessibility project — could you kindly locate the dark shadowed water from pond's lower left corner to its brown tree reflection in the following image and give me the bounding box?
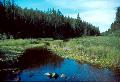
[0,47,64,81]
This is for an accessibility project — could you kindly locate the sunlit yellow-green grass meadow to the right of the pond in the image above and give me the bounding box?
[51,36,120,67]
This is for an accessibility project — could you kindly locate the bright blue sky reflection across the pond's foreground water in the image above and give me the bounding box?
[19,59,120,82]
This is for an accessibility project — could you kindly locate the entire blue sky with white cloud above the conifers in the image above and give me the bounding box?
[15,0,120,32]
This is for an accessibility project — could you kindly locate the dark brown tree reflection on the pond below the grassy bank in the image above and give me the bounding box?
[18,48,63,69]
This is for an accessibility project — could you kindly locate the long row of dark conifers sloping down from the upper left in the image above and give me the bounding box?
[0,0,100,39]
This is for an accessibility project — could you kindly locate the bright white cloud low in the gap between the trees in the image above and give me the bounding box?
[80,10,115,32]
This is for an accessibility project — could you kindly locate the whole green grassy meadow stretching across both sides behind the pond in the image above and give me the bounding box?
[0,36,120,68]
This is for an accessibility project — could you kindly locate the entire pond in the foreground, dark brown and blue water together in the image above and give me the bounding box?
[0,48,120,82]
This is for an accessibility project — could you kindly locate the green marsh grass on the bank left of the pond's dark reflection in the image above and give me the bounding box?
[0,39,44,61]
